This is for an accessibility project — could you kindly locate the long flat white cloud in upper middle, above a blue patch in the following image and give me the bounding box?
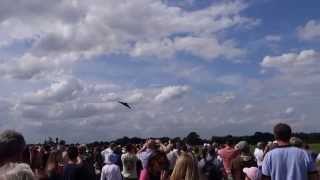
[131,36,245,60]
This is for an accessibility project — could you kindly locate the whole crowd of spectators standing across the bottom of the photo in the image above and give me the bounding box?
[0,123,320,180]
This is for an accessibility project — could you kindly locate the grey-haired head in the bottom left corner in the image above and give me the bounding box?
[0,163,35,180]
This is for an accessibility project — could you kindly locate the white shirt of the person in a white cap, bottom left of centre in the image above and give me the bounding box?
[100,164,122,180]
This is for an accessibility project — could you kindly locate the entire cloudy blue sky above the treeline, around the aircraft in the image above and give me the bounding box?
[0,0,320,142]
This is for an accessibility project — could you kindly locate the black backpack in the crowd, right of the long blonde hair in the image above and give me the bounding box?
[202,158,223,180]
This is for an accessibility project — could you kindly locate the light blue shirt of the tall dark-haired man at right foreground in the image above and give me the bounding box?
[262,146,316,180]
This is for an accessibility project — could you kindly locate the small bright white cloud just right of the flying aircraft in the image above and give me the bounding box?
[154,86,190,102]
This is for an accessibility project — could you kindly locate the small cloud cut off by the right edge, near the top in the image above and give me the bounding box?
[298,20,320,41]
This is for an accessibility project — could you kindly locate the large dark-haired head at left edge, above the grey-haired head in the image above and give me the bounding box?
[0,130,26,163]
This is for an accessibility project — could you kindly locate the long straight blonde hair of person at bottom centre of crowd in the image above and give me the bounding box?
[170,153,199,180]
